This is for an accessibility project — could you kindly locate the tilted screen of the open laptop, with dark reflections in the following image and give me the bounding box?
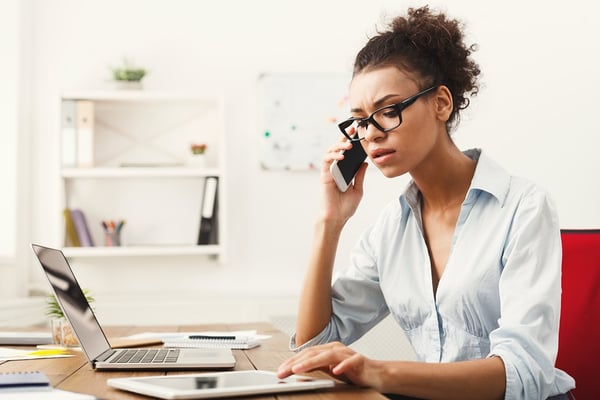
[31,244,110,362]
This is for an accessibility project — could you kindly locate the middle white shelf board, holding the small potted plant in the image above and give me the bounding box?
[62,167,221,179]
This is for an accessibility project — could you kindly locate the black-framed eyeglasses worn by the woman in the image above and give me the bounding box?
[338,86,438,142]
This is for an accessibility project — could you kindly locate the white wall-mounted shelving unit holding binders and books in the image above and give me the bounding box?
[60,90,226,259]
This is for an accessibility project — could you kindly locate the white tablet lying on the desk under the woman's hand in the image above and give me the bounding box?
[107,371,335,399]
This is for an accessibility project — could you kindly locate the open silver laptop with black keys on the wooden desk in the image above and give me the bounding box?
[31,244,235,371]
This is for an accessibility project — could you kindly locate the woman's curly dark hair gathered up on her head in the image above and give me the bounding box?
[353,6,480,130]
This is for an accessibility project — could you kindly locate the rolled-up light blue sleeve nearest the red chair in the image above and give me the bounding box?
[489,190,573,400]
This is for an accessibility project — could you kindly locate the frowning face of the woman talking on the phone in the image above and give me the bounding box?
[350,67,447,177]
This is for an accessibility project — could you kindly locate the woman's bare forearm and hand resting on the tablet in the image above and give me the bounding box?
[278,342,506,400]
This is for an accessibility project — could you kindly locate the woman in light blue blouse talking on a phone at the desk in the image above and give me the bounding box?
[278,7,574,399]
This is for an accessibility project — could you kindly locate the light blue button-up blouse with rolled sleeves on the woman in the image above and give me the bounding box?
[290,149,574,400]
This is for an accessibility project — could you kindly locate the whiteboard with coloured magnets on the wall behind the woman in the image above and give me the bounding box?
[258,74,350,170]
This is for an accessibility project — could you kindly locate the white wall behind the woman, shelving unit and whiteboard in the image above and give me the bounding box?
[9,0,600,322]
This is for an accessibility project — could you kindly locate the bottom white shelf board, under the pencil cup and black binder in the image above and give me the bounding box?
[63,245,222,258]
